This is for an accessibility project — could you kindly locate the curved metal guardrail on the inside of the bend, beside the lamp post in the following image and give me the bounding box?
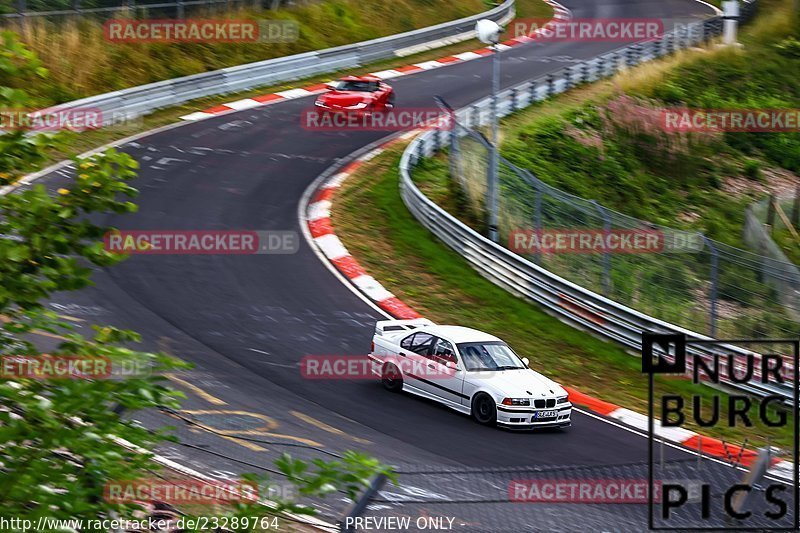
[400,0,793,401]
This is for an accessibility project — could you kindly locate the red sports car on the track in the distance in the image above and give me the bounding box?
[314,76,394,113]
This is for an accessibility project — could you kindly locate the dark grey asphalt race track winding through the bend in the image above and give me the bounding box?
[26,0,736,524]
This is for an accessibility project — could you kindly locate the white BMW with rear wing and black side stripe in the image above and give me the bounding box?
[370,319,572,428]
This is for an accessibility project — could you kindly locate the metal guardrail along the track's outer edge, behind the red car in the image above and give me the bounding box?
[29,0,514,126]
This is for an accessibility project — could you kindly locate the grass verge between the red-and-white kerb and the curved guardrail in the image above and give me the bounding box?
[332,144,791,447]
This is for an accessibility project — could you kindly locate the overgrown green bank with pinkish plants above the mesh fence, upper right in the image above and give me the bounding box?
[502,0,800,247]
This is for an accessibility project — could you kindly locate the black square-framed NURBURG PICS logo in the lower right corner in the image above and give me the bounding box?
[642,332,800,531]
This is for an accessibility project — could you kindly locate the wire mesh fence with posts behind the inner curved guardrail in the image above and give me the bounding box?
[450,126,800,338]
